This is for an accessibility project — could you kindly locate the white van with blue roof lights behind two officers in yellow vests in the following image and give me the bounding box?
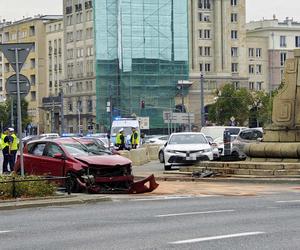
[110,118,141,147]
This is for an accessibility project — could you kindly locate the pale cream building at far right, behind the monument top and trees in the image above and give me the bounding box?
[247,16,300,91]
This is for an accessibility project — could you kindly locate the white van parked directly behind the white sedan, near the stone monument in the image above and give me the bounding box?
[201,126,247,156]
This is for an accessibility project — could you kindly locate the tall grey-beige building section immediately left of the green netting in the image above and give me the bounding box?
[62,0,96,133]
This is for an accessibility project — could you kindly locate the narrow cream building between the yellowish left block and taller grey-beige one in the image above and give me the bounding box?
[42,16,65,133]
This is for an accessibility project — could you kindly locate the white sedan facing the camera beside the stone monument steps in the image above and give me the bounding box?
[164,132,213,170]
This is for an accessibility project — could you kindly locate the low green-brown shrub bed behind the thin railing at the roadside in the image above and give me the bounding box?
[0,176,57,200]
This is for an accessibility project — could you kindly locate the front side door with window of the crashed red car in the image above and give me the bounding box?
[40,142,65,176]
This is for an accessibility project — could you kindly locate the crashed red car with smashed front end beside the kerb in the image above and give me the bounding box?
[15,138,158,193]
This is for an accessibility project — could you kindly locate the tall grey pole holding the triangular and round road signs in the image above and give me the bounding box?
[15,48,24,177]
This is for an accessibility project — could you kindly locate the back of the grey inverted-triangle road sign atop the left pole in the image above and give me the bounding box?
[0,43,34,72]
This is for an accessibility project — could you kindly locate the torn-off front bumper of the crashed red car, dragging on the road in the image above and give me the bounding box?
[77,174,159,194]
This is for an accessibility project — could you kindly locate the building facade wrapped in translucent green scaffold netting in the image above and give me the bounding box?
[94,0,189,129]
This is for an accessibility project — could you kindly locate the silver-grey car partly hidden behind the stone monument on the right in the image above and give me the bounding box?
[231,128,263,160]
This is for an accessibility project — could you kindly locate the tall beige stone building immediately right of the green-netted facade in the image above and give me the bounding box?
[188,0,248,127]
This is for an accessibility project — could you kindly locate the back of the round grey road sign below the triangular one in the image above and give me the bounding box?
[5,74,30,97]
